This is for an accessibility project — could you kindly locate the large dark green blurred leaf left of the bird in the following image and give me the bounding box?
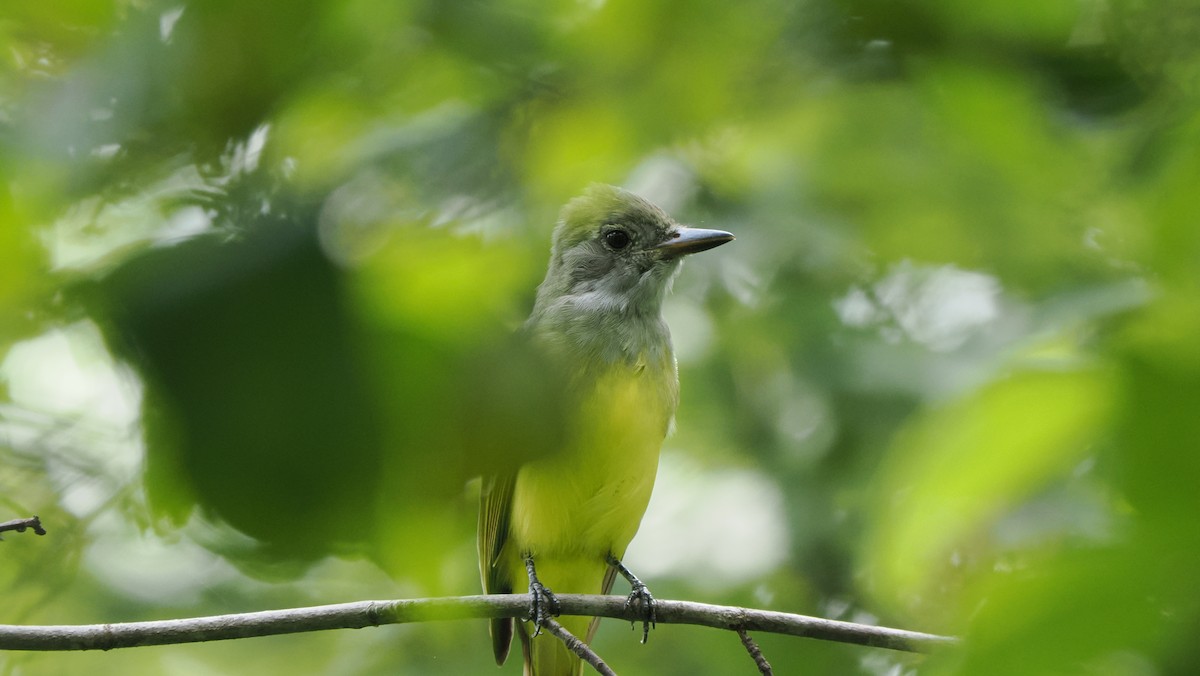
[91,226,383,557]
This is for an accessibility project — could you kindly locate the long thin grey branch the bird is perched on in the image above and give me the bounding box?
[0,594,956,652]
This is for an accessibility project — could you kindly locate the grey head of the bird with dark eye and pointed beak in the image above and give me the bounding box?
[538,184,733,313]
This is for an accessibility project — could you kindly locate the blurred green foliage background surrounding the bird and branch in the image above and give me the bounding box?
[0,0,1200,676]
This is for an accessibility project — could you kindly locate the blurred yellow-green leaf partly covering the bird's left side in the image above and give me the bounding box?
[353,230,566,586]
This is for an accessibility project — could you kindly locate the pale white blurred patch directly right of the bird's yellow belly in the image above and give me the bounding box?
[625,451,790,585]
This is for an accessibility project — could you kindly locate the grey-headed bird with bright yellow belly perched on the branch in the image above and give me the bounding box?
[479,185,733,676]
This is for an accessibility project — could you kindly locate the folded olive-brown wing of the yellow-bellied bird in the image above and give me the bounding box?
[478,474,516,664]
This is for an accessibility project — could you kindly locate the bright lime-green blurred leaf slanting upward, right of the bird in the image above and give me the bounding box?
[865,370,1112,605]
